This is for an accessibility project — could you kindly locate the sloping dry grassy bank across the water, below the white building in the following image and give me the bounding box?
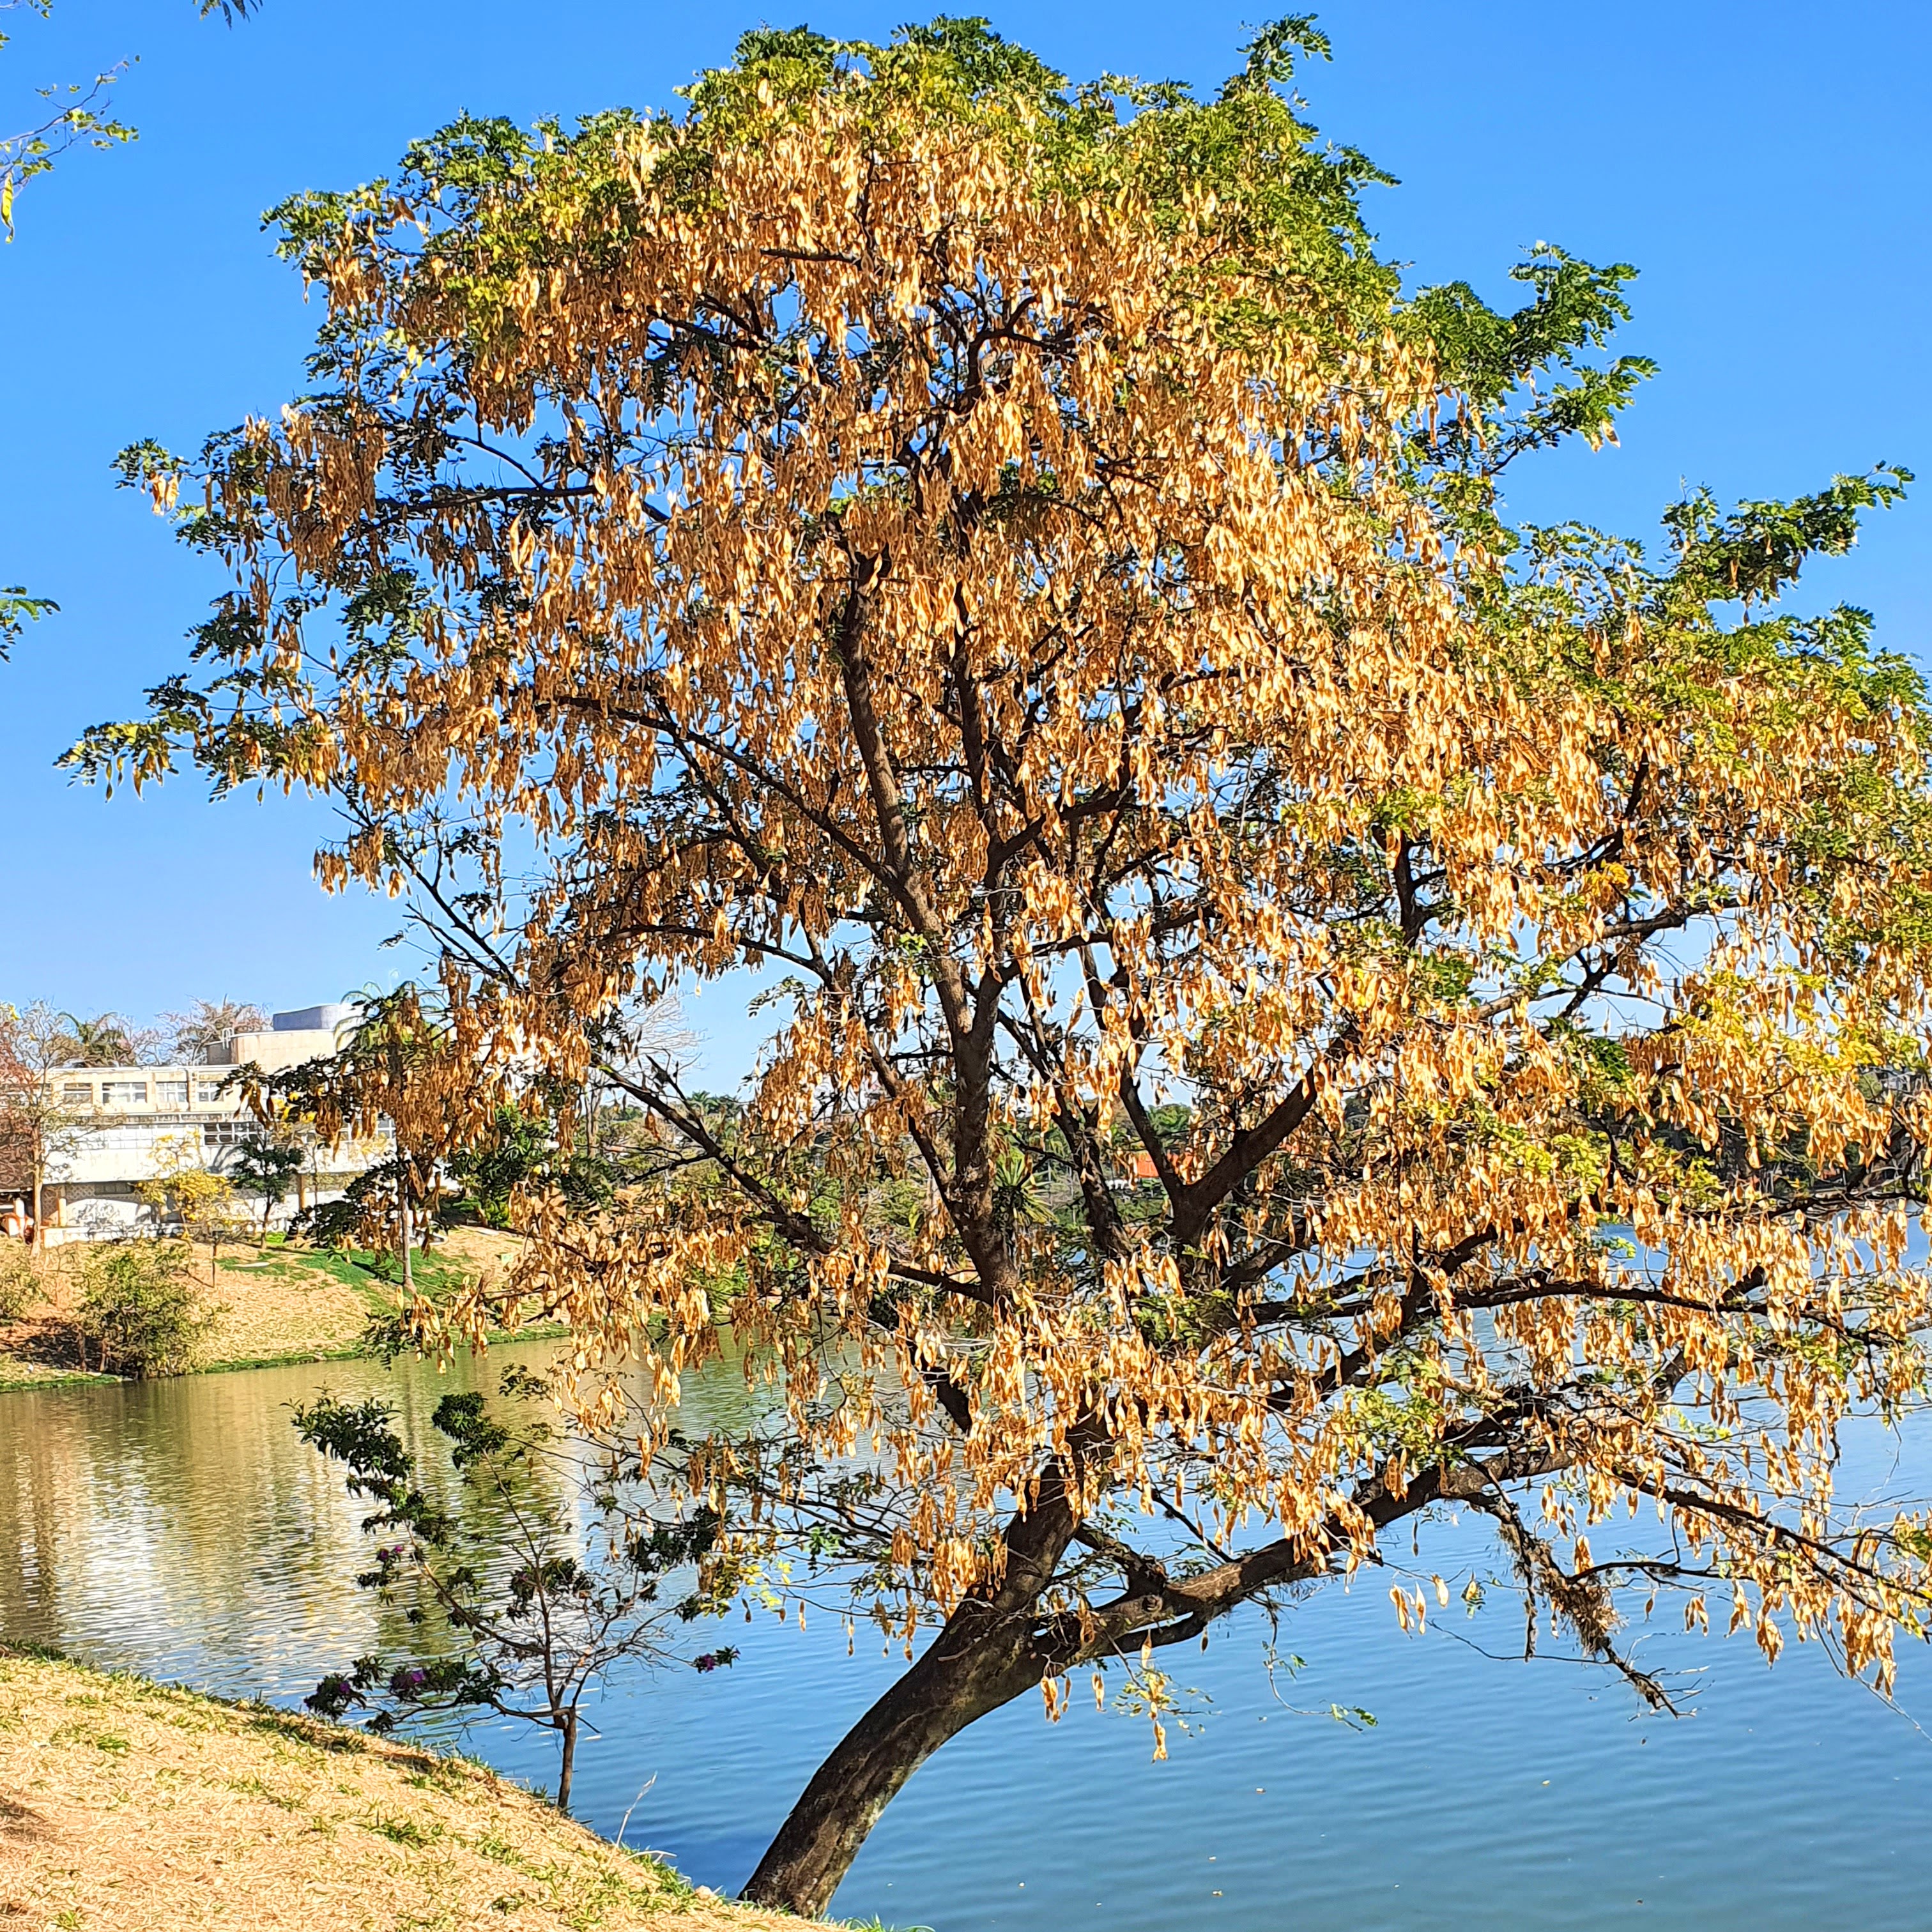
[0,1227,537,1389]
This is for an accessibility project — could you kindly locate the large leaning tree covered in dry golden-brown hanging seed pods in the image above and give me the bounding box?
[73,21,1932,1911]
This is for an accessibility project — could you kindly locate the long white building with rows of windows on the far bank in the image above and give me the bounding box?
[19,1007,387,1242]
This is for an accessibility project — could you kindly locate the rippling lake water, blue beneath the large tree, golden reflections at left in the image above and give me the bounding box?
[0,1351,1932,1932]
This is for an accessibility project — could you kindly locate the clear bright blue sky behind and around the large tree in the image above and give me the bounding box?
[0,0,1932,1076]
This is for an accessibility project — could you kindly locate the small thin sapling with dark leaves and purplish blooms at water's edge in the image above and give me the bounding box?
[296,1370,738,1810]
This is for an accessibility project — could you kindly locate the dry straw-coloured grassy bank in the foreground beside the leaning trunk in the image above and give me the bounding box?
[0,1648,823,1932]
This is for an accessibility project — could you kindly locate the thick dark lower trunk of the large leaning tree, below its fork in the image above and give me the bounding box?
[740,1600,1041,1919]
